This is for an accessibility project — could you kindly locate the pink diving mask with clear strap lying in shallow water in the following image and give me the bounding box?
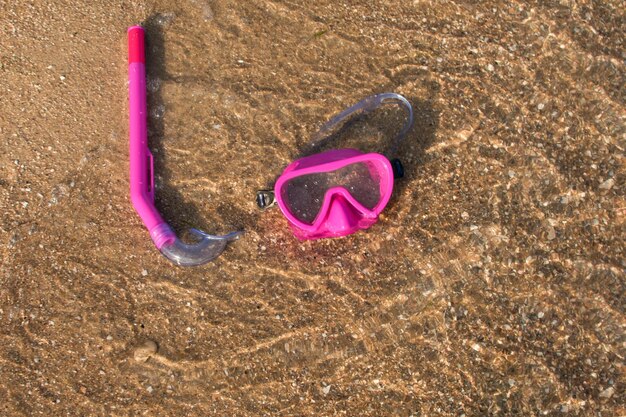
[257,93,413,240]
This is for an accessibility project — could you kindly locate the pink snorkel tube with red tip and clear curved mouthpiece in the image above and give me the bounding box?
[128,26,243,266]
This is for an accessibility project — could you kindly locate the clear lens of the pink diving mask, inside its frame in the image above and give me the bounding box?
[280,162,381,224]
